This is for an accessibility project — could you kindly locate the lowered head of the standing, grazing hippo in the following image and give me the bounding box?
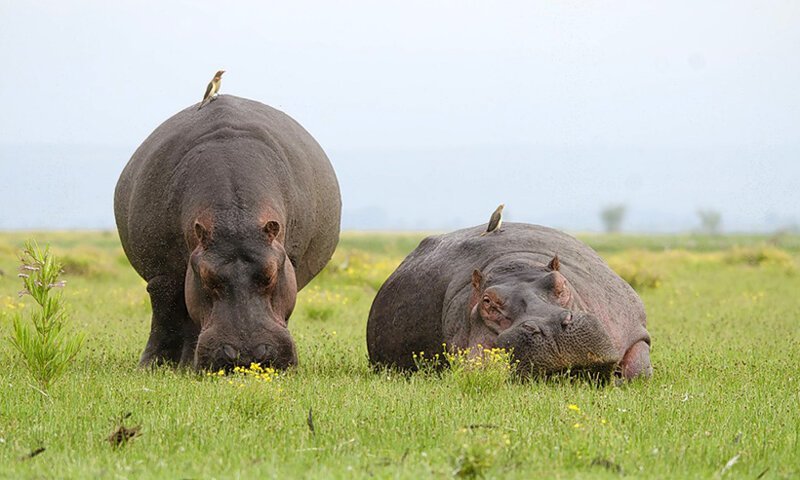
[185,220,297,370]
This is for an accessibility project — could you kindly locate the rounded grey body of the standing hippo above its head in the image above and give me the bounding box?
[114,95,341,288]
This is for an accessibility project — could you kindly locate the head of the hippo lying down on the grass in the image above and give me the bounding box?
[470,256,621,375]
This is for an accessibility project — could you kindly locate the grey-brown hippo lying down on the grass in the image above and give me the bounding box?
[367,223,652,379]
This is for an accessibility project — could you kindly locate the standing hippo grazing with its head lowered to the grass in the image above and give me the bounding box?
[114,95,341,369]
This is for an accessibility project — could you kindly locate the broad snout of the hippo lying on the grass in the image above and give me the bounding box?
[495,312,622,375]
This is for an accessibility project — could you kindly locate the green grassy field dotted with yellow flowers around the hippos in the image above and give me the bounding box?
[0,232,800,479]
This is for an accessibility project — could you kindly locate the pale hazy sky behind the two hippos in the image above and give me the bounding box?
[0,0,800,233]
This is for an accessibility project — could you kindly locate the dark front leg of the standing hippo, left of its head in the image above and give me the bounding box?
[139,275,197,367]
